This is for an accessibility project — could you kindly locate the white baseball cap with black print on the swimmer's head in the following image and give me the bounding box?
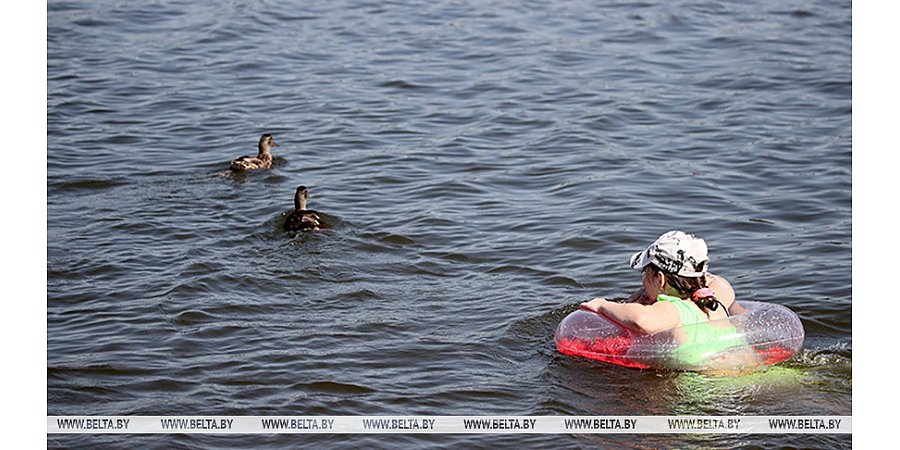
[631,231,709,278]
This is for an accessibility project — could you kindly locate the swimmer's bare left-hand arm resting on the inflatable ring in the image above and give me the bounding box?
[581,298,681,334]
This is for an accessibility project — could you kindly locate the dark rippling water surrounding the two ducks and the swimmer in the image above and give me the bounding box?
[47,0,852,448]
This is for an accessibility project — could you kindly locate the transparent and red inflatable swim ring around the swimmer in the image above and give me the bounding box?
[556,301,804,371]
